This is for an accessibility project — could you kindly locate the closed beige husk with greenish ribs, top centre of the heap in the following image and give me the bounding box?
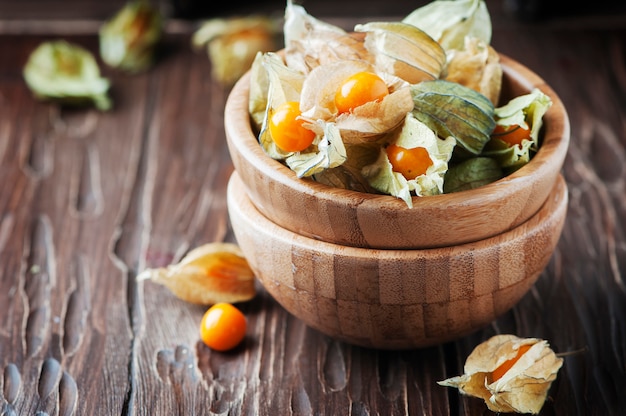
[354,22,446,84]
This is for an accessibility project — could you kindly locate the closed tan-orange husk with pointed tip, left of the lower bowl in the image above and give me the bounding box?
[137,243,256,305]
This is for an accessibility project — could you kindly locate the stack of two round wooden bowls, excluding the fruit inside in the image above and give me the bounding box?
[225,56,569,349]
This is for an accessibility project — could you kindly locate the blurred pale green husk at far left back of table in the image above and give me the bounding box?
[23,40,111,110]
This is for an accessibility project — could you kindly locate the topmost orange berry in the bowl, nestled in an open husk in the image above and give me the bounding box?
[335,72,389,114]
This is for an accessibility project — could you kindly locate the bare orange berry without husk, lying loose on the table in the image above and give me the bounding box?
[200,303,247,351]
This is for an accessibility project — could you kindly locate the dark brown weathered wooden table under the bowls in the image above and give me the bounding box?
[0,1,626,415]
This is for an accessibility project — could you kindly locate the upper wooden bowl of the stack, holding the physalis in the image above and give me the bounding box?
[224,56,569,248]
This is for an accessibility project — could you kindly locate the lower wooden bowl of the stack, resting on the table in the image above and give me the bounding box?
[228,172,568,349]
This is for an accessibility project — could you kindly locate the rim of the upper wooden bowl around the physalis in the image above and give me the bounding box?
[224,54,570,210]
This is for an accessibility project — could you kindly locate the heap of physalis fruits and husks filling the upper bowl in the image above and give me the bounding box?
[250,1,551,207]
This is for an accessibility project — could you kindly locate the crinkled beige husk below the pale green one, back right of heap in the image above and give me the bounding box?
[445,37,502,105]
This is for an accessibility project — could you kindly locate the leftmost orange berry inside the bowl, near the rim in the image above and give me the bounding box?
[269,101,315,152]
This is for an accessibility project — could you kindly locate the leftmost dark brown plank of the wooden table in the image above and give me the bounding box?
[0,37,146,414]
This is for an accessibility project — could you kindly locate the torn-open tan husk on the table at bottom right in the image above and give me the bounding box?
[438,335,563,414]
